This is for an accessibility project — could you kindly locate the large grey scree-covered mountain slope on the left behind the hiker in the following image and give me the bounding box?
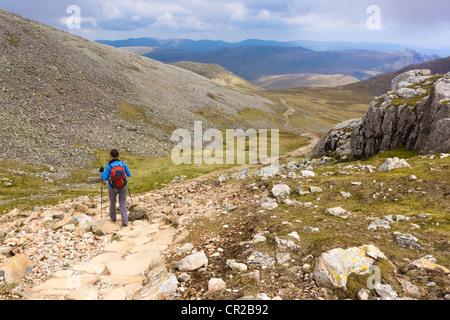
[0,10,274,166]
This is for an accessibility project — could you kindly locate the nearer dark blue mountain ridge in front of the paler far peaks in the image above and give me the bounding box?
[144,45,440,81]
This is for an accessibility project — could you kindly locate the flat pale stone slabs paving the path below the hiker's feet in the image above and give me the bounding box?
[31,216,176,300]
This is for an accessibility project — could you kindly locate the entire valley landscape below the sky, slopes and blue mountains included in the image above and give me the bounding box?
[0,9,450,300]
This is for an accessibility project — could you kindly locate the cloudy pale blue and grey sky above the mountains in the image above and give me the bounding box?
[0,0,450,48]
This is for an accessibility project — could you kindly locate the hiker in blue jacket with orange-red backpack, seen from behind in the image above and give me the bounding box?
[99,149,131,227]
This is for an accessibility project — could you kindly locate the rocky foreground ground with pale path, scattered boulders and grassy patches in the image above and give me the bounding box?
[0,151,450,300]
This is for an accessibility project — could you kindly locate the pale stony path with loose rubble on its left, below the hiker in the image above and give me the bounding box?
[0,194,183,300]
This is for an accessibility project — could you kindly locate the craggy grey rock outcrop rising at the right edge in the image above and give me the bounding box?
[314,70,450,158]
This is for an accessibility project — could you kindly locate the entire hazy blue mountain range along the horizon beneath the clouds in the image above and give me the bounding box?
[99,38,439,84]
